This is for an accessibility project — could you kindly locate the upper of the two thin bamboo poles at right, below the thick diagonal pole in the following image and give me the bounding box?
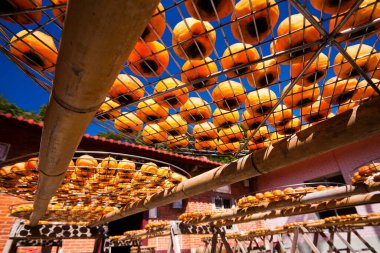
[183,183,380,224]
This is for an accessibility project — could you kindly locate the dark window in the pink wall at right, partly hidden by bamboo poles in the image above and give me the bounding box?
[305,172,357,219]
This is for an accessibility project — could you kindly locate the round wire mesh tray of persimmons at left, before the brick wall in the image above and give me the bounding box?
[0,151,190,209]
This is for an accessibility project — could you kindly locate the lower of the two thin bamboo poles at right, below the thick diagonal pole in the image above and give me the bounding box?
[220,193,380,226]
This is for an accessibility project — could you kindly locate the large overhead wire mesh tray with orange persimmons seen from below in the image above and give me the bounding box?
[0,0,380,156]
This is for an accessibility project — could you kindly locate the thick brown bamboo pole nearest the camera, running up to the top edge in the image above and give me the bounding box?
[30,0,158,225]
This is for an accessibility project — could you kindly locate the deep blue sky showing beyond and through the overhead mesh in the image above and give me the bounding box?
[0,0,379,134]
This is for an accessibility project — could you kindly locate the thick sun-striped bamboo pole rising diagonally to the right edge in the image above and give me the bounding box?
[91,97,380,226]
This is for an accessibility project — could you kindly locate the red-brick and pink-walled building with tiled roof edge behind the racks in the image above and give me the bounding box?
[0,114,380,253]
